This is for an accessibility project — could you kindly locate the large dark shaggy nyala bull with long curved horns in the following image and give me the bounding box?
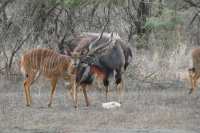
[63,33,132,106]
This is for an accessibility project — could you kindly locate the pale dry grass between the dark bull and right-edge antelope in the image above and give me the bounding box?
[129,44,192,81]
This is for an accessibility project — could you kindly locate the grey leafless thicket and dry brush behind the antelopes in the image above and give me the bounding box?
[0,0,200,80]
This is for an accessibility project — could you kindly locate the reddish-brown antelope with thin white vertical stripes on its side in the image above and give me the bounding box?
[20,48,75,107]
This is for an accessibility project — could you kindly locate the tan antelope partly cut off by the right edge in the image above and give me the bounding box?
[188,48,200,94]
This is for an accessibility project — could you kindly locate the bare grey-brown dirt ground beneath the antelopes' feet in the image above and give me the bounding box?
[0,77,200,133]
